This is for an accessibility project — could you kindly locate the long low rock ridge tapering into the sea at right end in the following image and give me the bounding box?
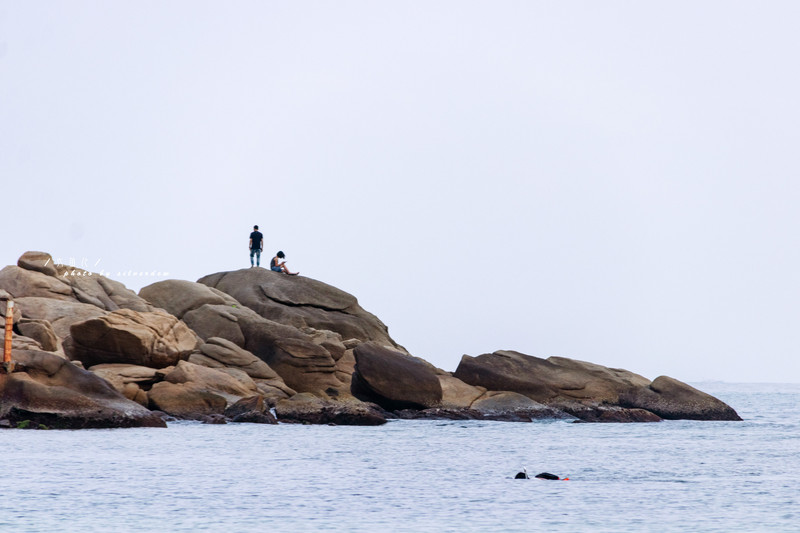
[454,351,739,422]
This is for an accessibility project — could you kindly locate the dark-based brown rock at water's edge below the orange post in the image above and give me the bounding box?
[0,350,166,429]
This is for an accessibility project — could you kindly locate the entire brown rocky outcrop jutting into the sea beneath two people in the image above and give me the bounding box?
[0,252,739,428]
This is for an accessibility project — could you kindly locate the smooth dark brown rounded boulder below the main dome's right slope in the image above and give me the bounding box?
[352,343,442,411]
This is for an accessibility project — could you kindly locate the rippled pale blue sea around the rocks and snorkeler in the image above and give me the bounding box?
[0,383,800,533]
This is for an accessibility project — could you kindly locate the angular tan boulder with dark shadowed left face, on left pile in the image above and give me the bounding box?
[65,309,200,368]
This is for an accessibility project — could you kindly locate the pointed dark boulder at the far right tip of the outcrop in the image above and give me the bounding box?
[621,376,741,420]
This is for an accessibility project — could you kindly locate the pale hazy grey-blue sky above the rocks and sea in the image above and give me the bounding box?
[0,0,800,382]
